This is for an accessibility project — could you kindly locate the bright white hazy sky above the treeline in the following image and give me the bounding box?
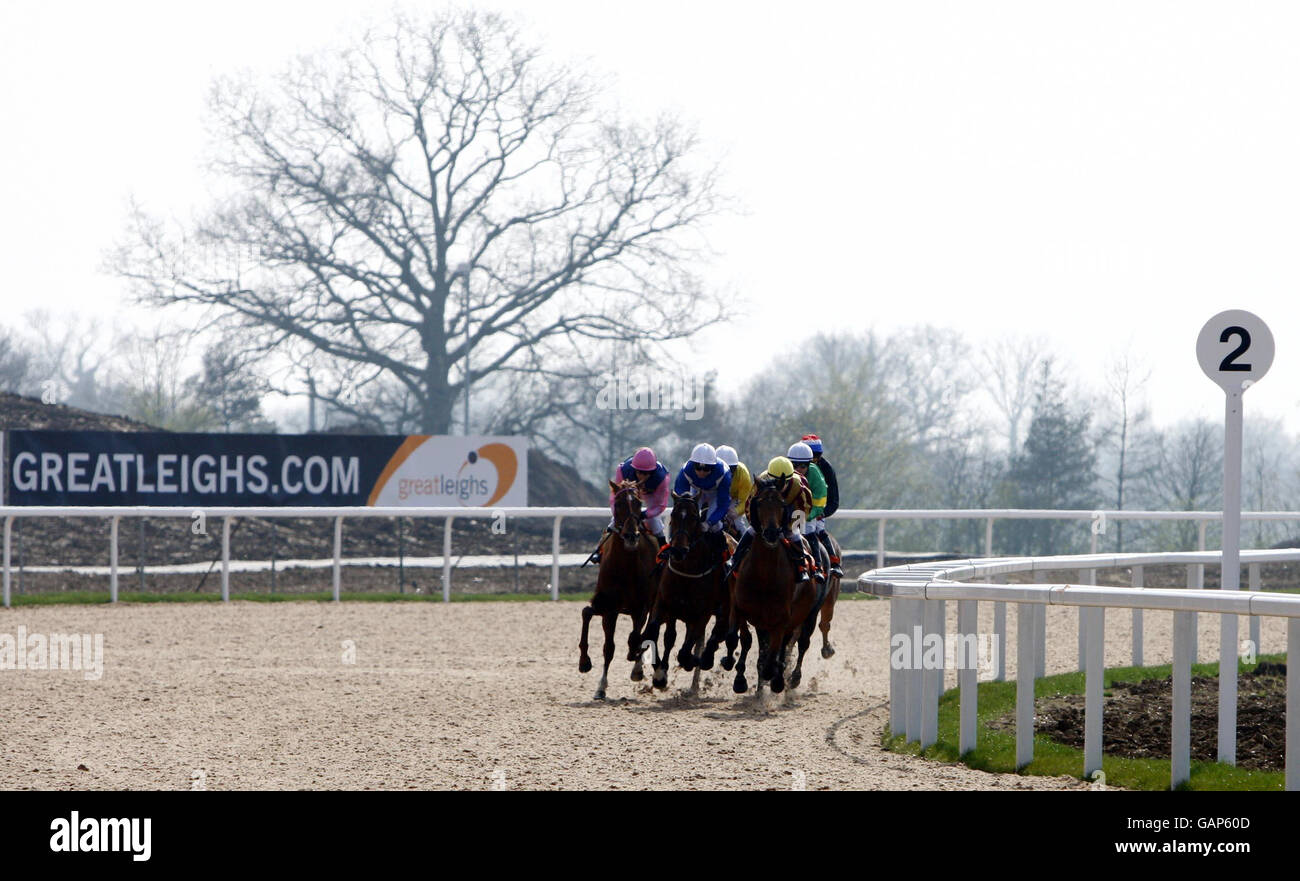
[0,0,1300,431]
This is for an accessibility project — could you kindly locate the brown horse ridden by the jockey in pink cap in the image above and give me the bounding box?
[577,481,659,700]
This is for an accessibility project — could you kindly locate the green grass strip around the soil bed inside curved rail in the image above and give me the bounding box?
[881,655,1286,791]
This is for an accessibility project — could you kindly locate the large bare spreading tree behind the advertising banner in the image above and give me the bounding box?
[112,10,722,433]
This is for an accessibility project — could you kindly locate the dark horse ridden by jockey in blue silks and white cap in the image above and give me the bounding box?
[644,492,731,691]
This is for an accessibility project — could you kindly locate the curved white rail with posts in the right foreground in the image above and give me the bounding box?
[858,550,1300,790]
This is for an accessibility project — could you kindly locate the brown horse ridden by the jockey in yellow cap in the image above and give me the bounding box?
[728,481,827,694]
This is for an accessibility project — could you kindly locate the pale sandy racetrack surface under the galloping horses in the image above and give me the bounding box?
[0,600,1282,790]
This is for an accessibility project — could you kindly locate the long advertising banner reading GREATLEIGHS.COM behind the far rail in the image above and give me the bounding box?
[5,430,528,508]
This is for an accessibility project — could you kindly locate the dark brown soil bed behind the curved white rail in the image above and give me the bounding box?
[1008,663,1287,771]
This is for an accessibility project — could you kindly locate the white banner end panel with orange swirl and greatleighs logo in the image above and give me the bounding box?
[368,435,528,507]
